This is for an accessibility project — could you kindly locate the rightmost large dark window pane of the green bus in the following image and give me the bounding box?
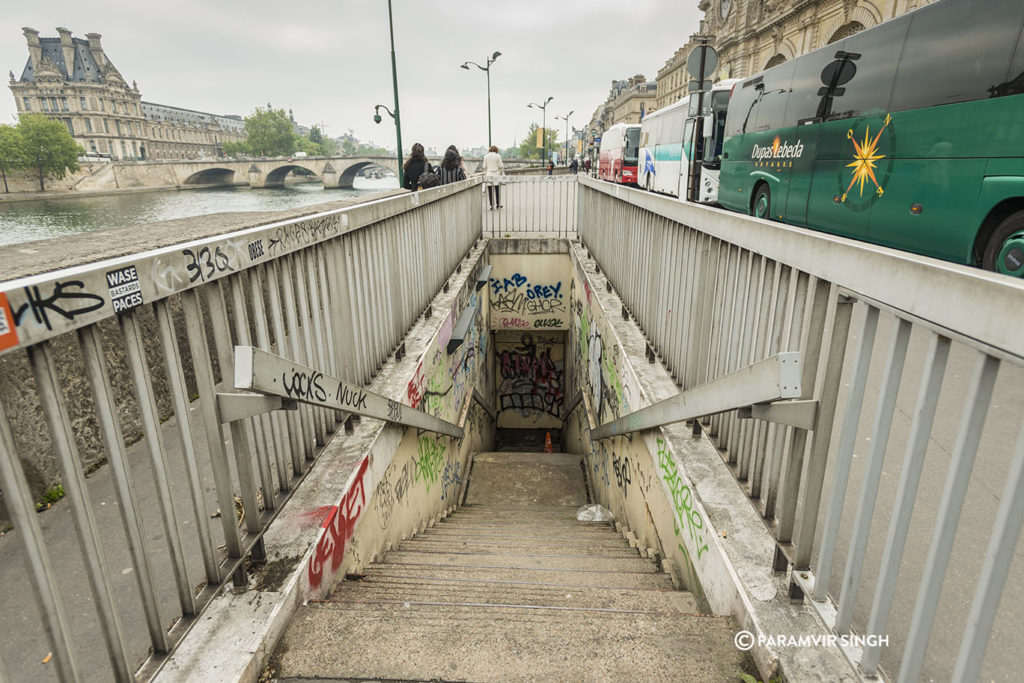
[892,0,1024,112]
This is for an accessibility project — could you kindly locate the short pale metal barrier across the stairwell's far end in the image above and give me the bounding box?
[482,175,579,238]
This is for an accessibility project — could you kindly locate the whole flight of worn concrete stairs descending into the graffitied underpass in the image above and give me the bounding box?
[270,453,753,681]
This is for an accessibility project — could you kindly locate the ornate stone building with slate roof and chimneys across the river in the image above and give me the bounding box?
[10,28,246,159]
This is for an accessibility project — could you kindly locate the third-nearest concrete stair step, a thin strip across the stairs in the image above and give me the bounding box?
[364,562,672,590]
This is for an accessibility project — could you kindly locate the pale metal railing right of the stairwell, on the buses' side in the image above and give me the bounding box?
[580,178,1024,681]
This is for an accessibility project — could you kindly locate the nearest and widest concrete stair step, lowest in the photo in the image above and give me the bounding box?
[276,603,744,682]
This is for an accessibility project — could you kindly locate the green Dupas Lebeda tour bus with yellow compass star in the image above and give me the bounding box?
[719,0,1024,276]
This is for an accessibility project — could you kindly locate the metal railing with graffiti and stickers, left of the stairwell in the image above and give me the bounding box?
[0,181,481,681]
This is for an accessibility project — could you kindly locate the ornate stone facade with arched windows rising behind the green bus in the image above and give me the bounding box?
[700,0,931,80]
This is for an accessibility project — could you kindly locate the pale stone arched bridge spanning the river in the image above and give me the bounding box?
[115,156,528,187]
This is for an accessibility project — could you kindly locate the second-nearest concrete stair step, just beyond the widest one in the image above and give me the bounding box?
[327,577,699,613]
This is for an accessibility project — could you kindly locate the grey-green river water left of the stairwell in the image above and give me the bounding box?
[0,175,398,246]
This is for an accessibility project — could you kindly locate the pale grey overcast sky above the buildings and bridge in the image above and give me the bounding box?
[0,0,700,154]
